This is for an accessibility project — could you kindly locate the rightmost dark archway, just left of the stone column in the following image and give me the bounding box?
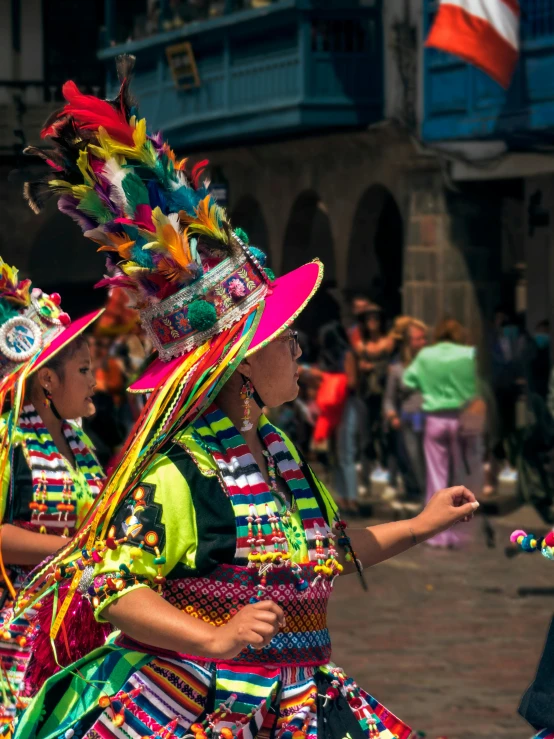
[346,184,404,318]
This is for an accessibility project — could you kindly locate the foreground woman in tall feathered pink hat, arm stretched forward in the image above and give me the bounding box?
[16,56,477,739]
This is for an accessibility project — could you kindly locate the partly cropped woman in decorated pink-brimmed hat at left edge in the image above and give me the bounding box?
[0,258,104,731]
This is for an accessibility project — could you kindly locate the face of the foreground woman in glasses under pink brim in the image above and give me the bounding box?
[239,329,302,408]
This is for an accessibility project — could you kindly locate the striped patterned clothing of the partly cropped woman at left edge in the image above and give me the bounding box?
[0,404,104,724]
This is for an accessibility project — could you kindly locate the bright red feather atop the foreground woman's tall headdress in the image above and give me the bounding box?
[40,80,134,146]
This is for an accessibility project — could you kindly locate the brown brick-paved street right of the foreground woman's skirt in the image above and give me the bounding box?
[330,509,554,739]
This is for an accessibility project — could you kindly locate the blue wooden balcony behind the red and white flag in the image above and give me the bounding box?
[423,0,554,141]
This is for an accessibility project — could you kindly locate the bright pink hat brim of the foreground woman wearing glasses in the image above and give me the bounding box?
[129,259,323,393]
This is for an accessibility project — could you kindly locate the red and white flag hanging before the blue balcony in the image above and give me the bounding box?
[425,0,520,88]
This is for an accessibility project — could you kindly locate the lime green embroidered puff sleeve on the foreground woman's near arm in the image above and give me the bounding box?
[93,456,198,621]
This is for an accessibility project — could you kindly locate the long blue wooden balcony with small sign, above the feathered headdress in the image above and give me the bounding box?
[99,0,383,149]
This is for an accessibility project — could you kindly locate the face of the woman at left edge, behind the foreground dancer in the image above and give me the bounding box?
[39,344,96,419]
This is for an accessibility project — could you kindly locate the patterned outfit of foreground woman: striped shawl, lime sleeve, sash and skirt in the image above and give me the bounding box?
[12,407,410,739]
